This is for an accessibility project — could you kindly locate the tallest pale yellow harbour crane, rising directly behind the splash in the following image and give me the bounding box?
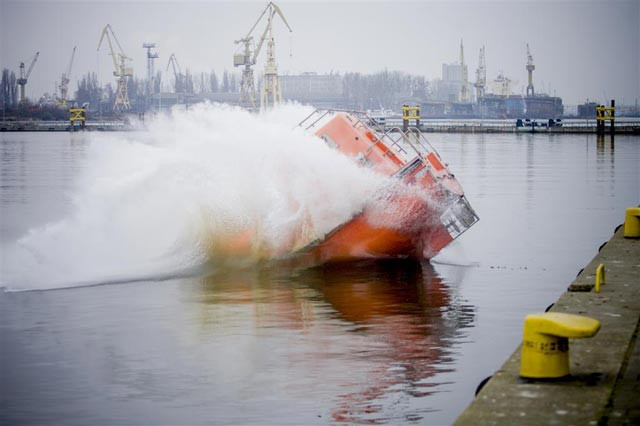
[233,2,292,109]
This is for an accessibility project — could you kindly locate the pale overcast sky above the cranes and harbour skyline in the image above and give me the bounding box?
[0,0,640,104]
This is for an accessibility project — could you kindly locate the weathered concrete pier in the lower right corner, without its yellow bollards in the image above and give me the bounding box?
[455,227,640,425]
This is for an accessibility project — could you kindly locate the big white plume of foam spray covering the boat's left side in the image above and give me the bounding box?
[1,104,387,290]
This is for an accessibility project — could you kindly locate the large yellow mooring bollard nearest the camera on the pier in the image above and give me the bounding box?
[520,312,600,379]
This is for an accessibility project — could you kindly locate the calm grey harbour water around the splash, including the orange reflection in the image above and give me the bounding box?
[0,128,640,425]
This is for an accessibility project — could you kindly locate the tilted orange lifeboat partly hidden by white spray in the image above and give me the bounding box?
[299,109,478,263]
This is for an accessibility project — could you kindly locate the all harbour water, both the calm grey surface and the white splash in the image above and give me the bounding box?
[0,107,640,425]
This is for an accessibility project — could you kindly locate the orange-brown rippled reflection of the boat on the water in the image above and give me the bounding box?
[199,260,474,423]
